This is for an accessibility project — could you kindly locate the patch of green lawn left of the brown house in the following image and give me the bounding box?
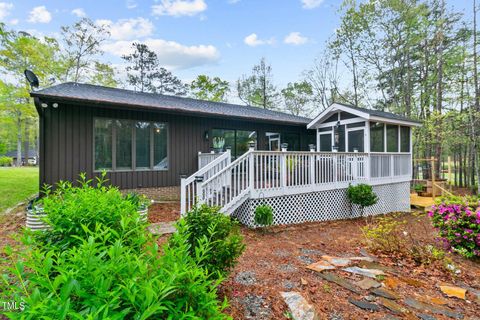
[0,167,38,213]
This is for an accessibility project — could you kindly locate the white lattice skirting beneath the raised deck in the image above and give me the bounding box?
[233,182,410,227]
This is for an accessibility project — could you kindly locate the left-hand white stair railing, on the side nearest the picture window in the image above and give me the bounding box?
[180,150,231,213]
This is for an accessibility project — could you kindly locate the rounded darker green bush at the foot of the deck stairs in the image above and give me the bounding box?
[180,205,245,277]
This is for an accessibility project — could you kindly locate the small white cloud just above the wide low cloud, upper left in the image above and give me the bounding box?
[95,17,154,40]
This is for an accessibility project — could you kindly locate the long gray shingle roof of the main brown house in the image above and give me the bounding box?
[30,82,311,125]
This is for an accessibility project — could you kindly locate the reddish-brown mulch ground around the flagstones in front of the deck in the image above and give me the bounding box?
[220,214,480,319]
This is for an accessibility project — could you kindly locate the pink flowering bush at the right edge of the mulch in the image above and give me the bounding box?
[428,197,480,258]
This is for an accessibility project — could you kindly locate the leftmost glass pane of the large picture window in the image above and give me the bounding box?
[94,119,113,170]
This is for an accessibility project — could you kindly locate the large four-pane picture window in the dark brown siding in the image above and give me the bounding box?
[94,118,168,171]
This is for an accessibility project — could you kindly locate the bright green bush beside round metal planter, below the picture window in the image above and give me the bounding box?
[35,174,143,250]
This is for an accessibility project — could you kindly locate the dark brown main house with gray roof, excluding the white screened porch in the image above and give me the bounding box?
[31,83,316,198]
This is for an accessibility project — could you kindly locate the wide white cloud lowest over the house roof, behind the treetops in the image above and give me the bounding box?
[103,38,220,70]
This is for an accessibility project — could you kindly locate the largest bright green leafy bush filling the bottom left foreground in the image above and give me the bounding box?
[2,222,228,319]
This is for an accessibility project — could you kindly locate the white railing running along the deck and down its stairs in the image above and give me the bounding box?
[182,150,411,214]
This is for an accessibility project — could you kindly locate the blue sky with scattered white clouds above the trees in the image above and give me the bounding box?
[0,0,472,91]
